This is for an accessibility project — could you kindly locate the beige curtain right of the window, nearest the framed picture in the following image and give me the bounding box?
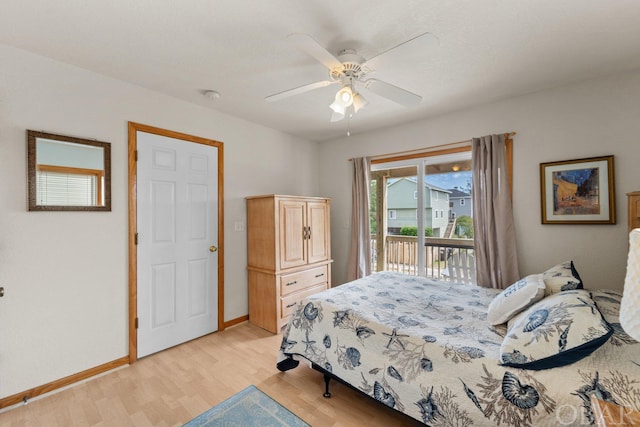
[471,135,520,289]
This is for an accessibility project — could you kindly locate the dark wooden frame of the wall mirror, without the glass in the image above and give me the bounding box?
[27,130,111,212]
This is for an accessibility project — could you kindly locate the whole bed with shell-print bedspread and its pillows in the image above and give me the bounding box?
[278,270,640,426]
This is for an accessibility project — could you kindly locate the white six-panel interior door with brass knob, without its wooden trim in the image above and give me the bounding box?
[137,131,218,357]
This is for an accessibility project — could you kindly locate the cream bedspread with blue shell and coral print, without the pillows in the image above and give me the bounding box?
[278,272,640,426]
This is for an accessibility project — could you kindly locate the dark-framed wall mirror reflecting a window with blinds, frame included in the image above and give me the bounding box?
[27,130,111,211]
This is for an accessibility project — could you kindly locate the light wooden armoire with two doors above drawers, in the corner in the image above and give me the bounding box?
[247,194,333,333]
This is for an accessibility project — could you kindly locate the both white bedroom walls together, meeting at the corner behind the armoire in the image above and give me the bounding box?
[0,41,640,404]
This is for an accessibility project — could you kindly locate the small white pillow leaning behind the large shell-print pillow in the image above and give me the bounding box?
[487,274,545,325]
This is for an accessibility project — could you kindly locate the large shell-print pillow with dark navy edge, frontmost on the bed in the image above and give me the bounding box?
[500,289,613,370]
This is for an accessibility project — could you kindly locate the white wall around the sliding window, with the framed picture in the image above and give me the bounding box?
[321,72,640,290]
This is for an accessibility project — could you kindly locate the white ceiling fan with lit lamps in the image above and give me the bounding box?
[265,33,436,122]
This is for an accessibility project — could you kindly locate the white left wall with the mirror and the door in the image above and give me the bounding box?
[0,45,319,398]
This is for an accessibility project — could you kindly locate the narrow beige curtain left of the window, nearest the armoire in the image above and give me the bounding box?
[347,157,371,280]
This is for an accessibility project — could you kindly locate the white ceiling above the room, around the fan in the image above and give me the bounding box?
[0,0,640,141]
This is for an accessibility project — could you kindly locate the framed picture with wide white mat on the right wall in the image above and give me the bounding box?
[540,156,616,224]
